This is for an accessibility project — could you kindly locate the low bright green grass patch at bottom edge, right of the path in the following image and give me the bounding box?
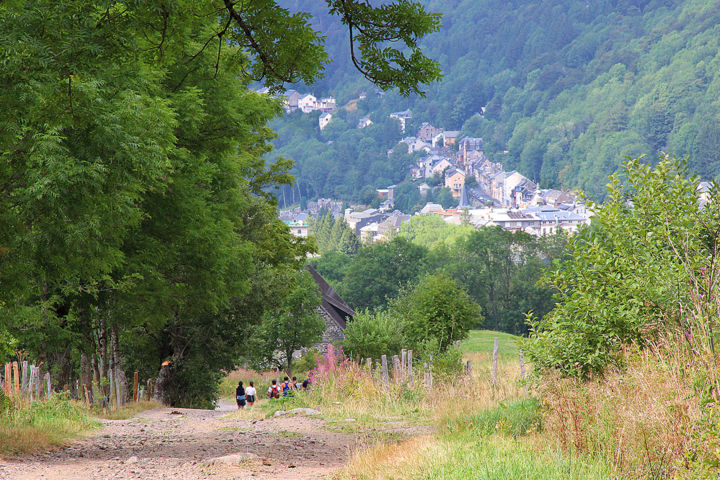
[412,433,615,480]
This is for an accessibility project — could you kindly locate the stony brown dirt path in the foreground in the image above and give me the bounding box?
[0,402,356,480]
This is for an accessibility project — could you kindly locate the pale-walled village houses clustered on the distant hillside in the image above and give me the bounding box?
[281,100,591,242]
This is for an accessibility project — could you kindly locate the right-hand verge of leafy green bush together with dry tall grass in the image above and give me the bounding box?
[523,157,720,480]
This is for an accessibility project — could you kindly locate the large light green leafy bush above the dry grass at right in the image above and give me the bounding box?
[524,157,717,376]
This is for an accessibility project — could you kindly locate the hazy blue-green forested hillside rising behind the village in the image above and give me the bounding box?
[276,0,720,200]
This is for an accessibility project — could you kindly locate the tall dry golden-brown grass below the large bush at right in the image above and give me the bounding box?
[540,335,719,479]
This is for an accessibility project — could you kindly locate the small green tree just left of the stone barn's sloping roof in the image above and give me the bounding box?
[248,272,325,375]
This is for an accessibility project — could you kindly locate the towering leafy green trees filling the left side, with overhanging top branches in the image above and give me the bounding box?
[0,0,438,406]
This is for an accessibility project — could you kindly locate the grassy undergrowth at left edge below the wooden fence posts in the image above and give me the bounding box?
[0,392,100,457]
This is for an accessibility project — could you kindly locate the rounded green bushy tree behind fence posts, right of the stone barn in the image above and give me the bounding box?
[390,273,483,354]
